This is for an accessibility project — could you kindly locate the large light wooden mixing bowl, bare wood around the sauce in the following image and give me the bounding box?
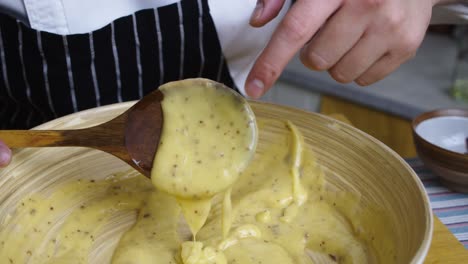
[0,102,433,263]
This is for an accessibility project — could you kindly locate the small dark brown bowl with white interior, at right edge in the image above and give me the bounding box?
[413,109,468,193]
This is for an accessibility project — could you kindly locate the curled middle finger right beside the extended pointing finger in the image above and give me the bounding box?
[300,5,369,71]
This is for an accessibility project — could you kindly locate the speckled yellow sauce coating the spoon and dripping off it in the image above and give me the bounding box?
[151,79,258,238]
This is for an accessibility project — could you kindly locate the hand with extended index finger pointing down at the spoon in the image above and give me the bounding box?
[246,0,439,98]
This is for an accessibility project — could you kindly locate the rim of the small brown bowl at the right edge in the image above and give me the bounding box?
[412,108,468,161]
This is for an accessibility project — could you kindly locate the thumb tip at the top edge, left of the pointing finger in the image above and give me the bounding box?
[250,0,286,27]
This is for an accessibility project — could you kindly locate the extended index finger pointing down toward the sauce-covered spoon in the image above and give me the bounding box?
[245,0,340,98]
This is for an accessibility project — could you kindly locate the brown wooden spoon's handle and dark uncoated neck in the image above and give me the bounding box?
[0,90,164,178]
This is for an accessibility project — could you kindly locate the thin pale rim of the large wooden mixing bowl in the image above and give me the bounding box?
[32,99,434,264]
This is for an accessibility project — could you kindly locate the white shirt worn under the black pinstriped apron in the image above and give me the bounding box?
[0,0,291,95]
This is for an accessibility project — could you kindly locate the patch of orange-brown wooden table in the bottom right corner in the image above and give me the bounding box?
[424,215,468,264]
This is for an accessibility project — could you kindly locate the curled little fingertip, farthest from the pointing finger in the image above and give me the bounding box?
[356,50,412,86]
